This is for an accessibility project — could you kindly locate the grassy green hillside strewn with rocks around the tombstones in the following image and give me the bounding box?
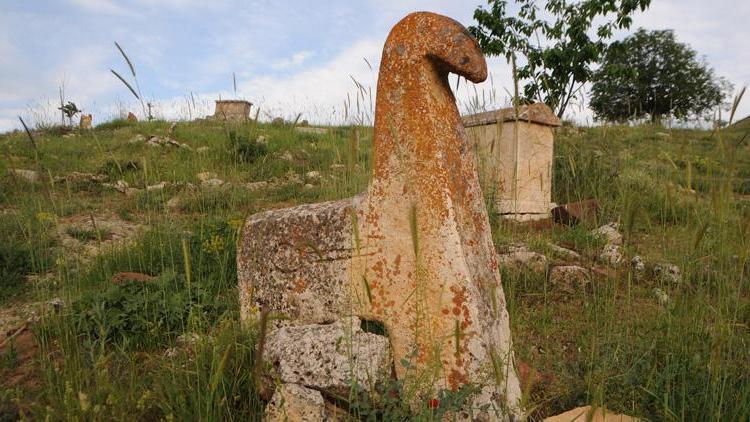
[0,121,750,420]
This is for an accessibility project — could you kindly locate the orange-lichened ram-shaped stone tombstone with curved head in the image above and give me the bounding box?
[237,12,521,420]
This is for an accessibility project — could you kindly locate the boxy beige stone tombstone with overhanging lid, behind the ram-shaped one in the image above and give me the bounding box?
[463,103,560,221]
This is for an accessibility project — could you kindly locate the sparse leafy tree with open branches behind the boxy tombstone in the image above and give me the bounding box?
[469,0,651,117]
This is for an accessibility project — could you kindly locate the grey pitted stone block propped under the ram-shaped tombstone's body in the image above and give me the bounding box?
[265,317,392,396]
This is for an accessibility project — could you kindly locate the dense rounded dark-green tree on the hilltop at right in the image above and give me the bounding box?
[590,29,731,123]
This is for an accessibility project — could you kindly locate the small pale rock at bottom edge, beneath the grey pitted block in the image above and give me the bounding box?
[263,384,327,422]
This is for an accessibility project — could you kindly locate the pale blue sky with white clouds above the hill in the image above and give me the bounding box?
[0,0,750,131]
